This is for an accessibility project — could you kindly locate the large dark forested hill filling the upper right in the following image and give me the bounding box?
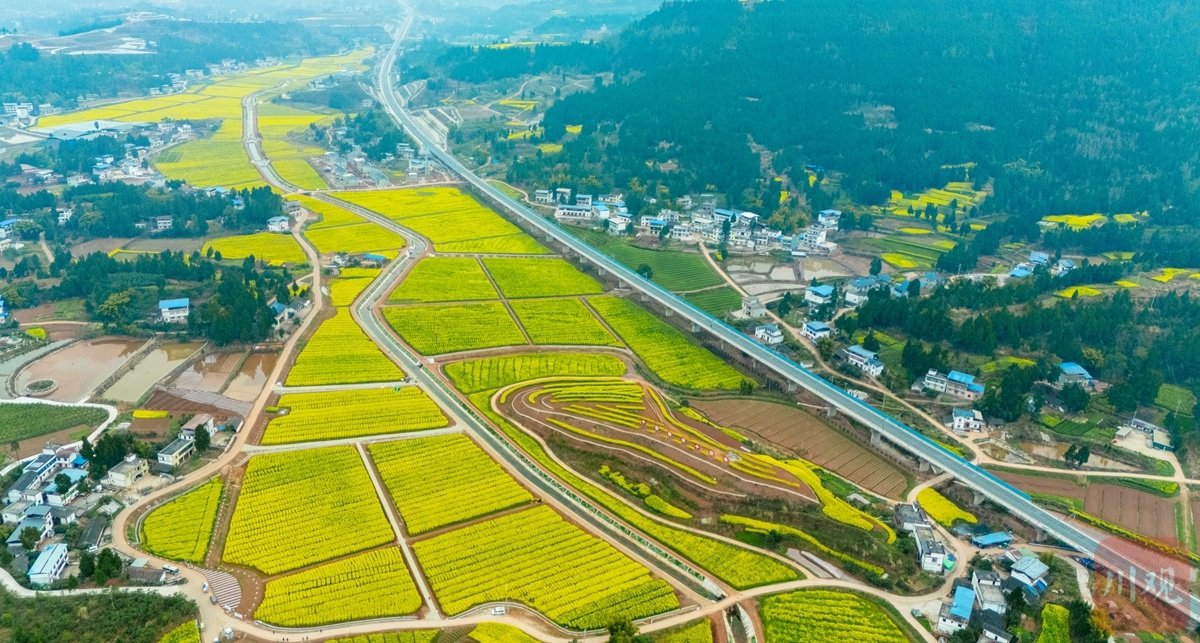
[520,0,1200,216]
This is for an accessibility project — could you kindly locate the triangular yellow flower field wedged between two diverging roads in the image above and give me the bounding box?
[287,308,404,386]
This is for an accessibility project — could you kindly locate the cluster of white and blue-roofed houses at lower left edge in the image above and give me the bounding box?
[0,414,242,588]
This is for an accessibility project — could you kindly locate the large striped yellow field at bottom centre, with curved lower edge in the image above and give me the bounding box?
[413,506,679,629]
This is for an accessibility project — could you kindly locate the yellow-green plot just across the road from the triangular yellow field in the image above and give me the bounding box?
[383,301,528,355]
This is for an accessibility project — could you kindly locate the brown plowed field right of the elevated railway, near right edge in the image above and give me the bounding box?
[996,471,1178,545]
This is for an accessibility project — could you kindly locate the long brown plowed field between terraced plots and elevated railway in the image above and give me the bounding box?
[691,399,907,498]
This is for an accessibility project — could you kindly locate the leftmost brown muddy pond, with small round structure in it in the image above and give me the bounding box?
[16,337,144,402]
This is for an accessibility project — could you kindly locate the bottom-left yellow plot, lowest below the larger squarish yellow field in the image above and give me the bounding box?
[254,547,421,627]
